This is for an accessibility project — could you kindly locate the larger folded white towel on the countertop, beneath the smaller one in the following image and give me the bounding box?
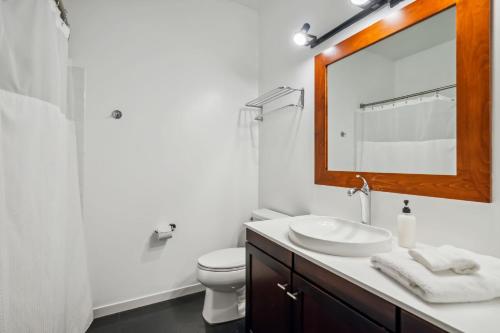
[371,250,500,303]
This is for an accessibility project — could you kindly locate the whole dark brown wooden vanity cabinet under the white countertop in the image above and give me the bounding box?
[246,230,444,333]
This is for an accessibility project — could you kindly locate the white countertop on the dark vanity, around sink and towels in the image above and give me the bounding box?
[246,217,500,333]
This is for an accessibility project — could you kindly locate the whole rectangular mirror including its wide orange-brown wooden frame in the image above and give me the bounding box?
[314,0,492,202]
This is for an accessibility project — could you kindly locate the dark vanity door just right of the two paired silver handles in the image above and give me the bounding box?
[292,274,386,333]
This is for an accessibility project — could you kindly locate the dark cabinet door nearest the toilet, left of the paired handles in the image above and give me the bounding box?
[246,243,291,333]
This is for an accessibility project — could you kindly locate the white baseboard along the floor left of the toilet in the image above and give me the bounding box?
[94,283,205,318]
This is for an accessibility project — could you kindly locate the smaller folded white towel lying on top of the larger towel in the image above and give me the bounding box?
[408,245,480,274]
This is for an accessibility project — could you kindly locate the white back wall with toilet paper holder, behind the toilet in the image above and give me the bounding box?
[66,0,258,307]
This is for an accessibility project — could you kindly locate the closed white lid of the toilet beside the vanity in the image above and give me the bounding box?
[198,247,245,270]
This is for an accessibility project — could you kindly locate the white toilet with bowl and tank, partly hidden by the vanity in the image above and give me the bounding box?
[197,209,289,324]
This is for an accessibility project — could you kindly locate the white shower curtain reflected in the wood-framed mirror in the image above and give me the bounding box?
[355,91,457,175]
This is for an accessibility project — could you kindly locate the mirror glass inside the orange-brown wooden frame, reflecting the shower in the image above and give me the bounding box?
[328,8,457,175]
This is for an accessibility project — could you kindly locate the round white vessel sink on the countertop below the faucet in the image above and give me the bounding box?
[288,216,392,257]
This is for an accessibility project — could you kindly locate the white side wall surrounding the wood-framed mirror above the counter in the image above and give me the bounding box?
[259,0,500,256]
